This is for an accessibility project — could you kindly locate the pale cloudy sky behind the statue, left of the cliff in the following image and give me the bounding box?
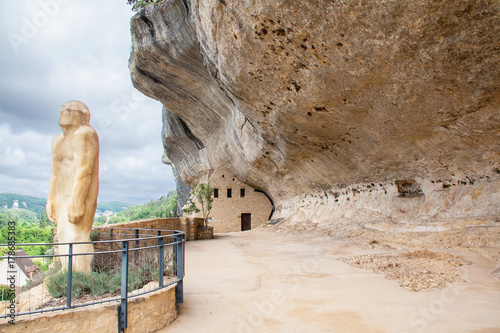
[0,0,175,204]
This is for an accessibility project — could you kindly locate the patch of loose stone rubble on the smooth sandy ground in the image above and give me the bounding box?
[341,250,472,291]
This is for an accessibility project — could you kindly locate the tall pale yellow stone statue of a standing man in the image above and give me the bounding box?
[47,101,99,272]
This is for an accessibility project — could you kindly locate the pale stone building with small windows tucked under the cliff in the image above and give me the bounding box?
[186,170,273,232]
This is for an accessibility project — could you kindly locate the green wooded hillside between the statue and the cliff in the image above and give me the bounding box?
[94,191,177,225]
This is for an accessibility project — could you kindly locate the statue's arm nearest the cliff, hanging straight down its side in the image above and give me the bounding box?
[68,127,99,223]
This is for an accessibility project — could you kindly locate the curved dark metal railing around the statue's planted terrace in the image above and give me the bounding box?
[0,227,185,332]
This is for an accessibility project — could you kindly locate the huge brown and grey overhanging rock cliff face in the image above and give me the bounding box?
[130,0,500,223]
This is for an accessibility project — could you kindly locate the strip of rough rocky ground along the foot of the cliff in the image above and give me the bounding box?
[274,217,500,264]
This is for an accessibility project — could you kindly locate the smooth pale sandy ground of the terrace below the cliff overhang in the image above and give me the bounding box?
[159,229,500,333]
